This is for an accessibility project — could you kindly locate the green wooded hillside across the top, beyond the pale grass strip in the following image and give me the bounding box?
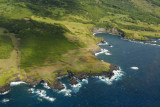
[0,0,160,40]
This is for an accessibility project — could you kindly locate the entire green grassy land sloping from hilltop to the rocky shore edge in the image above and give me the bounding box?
[0,0,160,86]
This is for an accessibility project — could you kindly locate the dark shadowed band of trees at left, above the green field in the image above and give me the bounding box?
[0,17,69,38]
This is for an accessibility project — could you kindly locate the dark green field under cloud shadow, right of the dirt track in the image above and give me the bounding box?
[1,19,79,69]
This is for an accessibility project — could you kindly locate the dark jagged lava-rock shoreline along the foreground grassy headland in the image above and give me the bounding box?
[0,65,119,94]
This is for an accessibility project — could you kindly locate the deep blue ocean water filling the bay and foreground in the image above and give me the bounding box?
[0,33,160,107]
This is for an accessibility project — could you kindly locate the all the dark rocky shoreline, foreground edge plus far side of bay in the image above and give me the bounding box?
[0,29,160,94]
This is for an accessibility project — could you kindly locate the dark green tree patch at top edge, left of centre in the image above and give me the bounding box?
[5,0,82,17]
